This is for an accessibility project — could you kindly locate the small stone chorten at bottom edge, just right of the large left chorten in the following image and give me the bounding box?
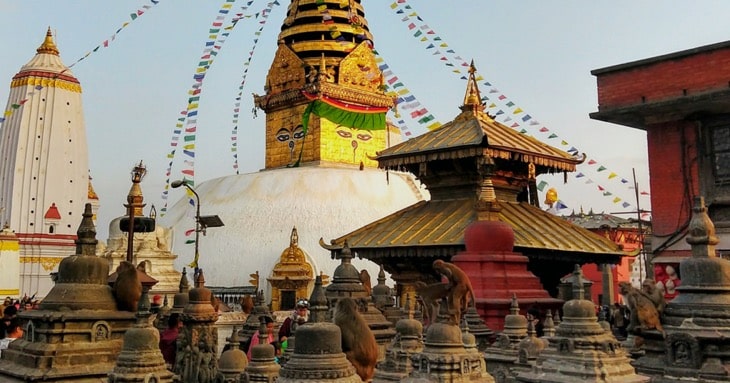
[109,291,173,383]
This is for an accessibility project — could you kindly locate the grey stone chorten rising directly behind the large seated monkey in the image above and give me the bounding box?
[325,243,395,361]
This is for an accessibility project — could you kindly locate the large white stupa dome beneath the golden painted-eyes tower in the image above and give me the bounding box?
[160,166,429,297]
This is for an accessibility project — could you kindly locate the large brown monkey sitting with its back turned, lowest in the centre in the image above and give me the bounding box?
[333,298,378,382]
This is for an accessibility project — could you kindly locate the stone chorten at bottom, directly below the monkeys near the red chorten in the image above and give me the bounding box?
[402,305,494,383]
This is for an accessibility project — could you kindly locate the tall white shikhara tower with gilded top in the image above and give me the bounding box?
[0,28,98,297]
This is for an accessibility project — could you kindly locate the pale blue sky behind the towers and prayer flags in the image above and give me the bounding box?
[0,0,730,240]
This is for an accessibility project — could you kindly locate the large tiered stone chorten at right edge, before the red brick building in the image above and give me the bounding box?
[635,197,730,383]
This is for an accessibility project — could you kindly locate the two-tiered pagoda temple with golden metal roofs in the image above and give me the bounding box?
[321,64,623,314]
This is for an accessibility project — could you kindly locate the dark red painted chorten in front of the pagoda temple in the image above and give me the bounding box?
[451,221,562,332]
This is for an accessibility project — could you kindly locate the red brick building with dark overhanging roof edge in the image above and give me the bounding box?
[591,41,730,297]
